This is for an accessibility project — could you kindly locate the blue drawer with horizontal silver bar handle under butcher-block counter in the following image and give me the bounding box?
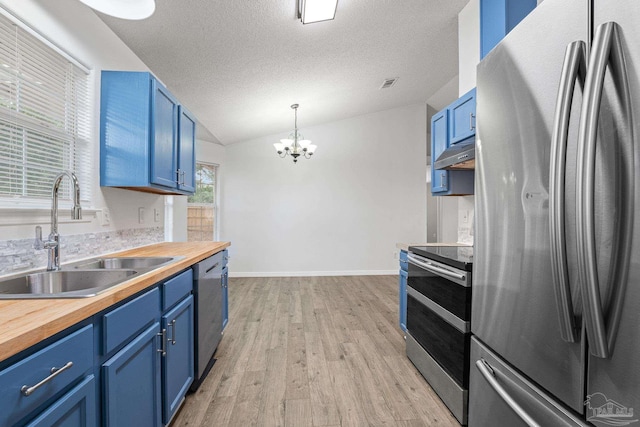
[0,325,93,426]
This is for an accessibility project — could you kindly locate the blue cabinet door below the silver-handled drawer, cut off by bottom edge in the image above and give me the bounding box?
[27,375,98,427]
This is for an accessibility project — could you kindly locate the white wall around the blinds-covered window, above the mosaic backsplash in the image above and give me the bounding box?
[0,0,164,240]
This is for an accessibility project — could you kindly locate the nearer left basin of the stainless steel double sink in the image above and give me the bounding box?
[0,269,138,299]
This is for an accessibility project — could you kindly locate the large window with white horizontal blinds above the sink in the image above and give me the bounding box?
[0,10,92,206]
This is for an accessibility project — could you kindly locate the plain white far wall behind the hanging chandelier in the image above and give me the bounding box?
[221,105,426,276]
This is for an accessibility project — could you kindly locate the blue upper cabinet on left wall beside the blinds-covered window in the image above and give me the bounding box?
[100,71,196,194]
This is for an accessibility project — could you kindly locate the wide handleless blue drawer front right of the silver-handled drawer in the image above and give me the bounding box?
[102,288,160,354]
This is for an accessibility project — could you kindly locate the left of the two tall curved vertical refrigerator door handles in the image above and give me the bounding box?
[549,40,587,342]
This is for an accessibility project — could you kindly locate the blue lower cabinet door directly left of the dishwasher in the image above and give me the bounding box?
[162,295,194,424]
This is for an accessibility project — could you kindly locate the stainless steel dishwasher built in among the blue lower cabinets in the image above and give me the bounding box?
[191,250,227,391]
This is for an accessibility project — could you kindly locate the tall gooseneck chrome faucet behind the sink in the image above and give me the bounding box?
[34,171,82,271]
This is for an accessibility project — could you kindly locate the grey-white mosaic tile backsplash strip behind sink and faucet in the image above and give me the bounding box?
[0,227,164,275]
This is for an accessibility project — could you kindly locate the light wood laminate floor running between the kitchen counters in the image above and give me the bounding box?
[173,276,459,427]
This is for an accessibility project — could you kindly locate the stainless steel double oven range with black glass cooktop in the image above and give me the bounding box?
[407,246,473,425]
